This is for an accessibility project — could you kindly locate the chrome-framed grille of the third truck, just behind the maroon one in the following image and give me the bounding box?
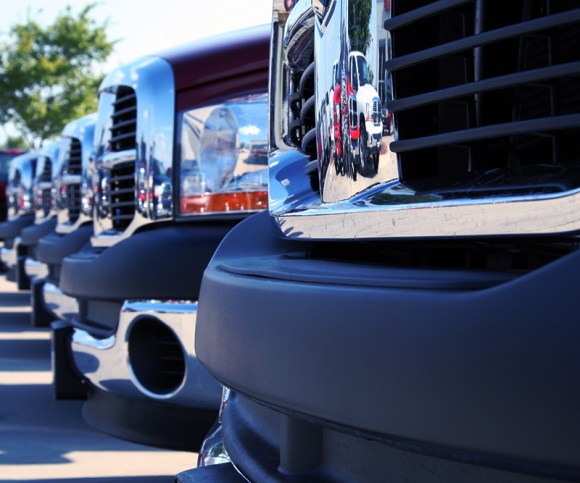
[56,114,97,234]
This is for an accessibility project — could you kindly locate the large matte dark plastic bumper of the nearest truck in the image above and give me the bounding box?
[196,214,580,481]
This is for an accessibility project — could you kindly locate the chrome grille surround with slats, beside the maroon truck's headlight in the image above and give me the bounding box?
[90,57,175,247]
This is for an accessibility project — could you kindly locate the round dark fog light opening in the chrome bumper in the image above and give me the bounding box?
[128,317,185,397]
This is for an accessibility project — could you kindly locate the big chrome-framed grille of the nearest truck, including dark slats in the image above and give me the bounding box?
[270,0,580,240]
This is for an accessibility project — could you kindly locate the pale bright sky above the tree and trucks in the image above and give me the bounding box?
[0,0,272,144]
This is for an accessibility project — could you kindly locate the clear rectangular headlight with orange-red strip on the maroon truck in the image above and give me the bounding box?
[179,95,268,215]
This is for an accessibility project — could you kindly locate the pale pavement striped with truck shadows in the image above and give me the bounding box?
[0,275,197,483]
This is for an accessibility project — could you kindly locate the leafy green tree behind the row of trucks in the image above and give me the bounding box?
[0,4,115,148]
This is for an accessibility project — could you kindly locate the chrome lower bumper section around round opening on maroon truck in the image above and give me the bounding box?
[72,301,221,409]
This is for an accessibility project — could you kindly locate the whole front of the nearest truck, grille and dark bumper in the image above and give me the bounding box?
[180,0,580,482]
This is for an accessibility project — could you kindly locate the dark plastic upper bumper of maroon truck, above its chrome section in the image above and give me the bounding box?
[60,223,233,337]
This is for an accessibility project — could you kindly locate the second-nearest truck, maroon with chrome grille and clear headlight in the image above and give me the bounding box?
[53,27,269,450]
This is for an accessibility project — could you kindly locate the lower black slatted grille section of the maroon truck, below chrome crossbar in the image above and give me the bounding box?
[109,161,135,231]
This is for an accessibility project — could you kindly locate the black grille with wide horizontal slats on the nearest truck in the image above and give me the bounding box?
[385,0,580,194]
